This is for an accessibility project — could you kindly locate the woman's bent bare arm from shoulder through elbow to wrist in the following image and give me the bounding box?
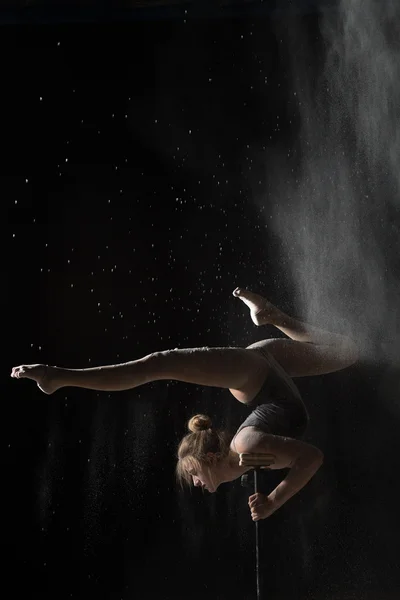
[236,432,324,516]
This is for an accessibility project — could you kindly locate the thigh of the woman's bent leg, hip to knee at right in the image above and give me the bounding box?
[248,338,355,377]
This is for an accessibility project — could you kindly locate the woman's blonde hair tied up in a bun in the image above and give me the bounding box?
[176,415,232,488]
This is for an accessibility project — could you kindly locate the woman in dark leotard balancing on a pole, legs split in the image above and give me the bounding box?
[11,288,358,521]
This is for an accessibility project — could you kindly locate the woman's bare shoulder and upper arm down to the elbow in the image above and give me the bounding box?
[233,427,323,469]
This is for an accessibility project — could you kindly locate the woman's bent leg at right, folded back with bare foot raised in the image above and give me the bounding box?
[234,288,358,377]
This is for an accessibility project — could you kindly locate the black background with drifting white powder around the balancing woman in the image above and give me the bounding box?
[1,3,400,600]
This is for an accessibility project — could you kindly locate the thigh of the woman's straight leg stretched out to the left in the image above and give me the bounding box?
[150,347,268,391]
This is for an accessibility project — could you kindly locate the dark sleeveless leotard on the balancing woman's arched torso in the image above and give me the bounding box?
[235,348,309,439]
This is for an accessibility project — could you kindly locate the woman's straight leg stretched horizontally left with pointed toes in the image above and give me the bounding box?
[11,348,266,394]
